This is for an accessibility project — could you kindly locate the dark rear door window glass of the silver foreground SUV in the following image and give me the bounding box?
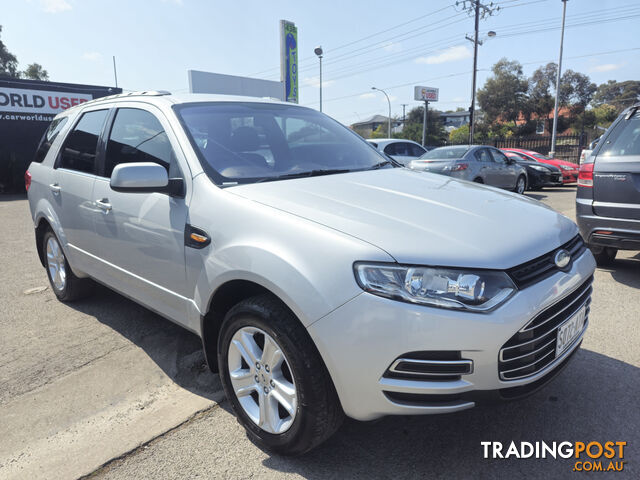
[58,110,108,173]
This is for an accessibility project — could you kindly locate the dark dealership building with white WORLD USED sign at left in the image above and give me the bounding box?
[0,77,122,192]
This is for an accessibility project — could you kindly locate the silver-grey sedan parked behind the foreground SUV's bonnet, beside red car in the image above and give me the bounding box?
[409,145,527,194]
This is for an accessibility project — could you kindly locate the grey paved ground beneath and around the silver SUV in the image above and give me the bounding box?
[0,188,640,479]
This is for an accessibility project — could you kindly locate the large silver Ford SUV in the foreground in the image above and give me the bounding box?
[25,92,595,454]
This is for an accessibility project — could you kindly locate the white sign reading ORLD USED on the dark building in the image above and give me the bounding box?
[0,86,93,115]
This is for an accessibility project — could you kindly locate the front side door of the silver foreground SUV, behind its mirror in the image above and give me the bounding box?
[93,103,189,320]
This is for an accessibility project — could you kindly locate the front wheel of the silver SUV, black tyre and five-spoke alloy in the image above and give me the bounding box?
[218,295,344,455]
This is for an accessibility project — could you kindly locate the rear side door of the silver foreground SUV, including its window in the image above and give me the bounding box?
[49,107,109,274]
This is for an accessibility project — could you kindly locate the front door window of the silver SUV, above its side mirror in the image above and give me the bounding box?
[104,108,181,178]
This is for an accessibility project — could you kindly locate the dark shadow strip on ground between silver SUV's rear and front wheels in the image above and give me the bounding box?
[68,285,222,402]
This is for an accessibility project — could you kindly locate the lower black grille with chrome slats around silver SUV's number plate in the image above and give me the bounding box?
[498,277,593,380]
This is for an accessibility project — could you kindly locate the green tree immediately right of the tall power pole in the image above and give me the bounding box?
[477,58,529,123]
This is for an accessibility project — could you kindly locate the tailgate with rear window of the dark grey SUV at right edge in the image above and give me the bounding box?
[591,108,640,220]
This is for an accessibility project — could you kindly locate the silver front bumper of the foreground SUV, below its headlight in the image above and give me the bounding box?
[309,251,595,420]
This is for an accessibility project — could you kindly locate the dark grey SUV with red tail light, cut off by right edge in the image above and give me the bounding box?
[576,102,640,265]
